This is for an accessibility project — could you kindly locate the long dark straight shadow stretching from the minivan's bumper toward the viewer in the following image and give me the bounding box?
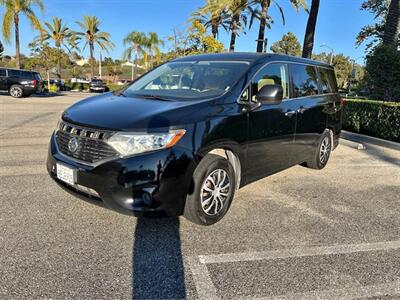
[132,218,186,299]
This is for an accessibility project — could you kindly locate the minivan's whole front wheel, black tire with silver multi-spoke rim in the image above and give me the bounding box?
[184,154,236,225]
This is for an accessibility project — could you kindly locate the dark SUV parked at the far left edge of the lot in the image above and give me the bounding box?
[0,68,43,98]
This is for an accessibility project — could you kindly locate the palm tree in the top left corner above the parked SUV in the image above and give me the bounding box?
[0,0,44,69]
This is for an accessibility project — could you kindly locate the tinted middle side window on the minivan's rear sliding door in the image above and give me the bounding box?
[290,64,318,98]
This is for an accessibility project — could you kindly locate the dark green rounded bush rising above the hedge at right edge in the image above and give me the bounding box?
[366,46,400,101]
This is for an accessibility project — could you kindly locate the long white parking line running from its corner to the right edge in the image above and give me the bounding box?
[199,241,400,264]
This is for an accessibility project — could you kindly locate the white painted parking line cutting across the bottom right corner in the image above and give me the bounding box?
[251,280,400,300]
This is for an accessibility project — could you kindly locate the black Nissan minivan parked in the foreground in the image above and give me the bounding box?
[47,53,343,225]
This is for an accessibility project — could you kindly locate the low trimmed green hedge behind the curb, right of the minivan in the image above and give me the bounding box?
[342,99,400,142]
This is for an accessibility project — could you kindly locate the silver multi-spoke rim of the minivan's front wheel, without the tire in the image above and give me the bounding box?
[200,169,231,216]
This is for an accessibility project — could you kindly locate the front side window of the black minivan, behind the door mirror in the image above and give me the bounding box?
[251,63,289,102]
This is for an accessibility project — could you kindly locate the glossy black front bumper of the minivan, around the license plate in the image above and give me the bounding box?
[47,134,196,216]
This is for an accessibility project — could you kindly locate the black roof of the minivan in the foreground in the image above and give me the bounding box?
[174,52,332,68]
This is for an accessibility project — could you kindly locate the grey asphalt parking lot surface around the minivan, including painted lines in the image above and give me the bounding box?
[0,94,400,299]
